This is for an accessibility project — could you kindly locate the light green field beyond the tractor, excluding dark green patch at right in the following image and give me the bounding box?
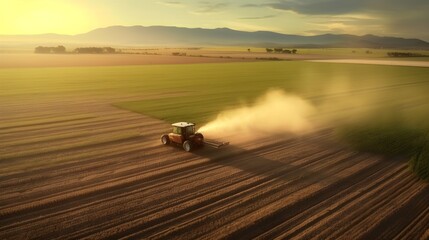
[0,62,429,124]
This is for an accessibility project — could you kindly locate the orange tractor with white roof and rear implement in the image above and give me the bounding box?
[161,122,229,152]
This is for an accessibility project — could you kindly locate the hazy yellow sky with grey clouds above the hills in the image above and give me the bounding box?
[0,0,429,41]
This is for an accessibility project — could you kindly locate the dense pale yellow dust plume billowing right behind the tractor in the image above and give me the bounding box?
[198,89,315,140]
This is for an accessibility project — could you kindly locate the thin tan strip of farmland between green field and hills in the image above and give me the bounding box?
[0,46,429,68]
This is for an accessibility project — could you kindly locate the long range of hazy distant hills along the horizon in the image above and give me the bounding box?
[0,26,429,49]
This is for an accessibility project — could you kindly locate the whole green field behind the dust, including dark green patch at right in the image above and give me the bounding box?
[0,61,429,176]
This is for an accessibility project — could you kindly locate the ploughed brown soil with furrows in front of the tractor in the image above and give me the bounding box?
[0,93,429,239]
